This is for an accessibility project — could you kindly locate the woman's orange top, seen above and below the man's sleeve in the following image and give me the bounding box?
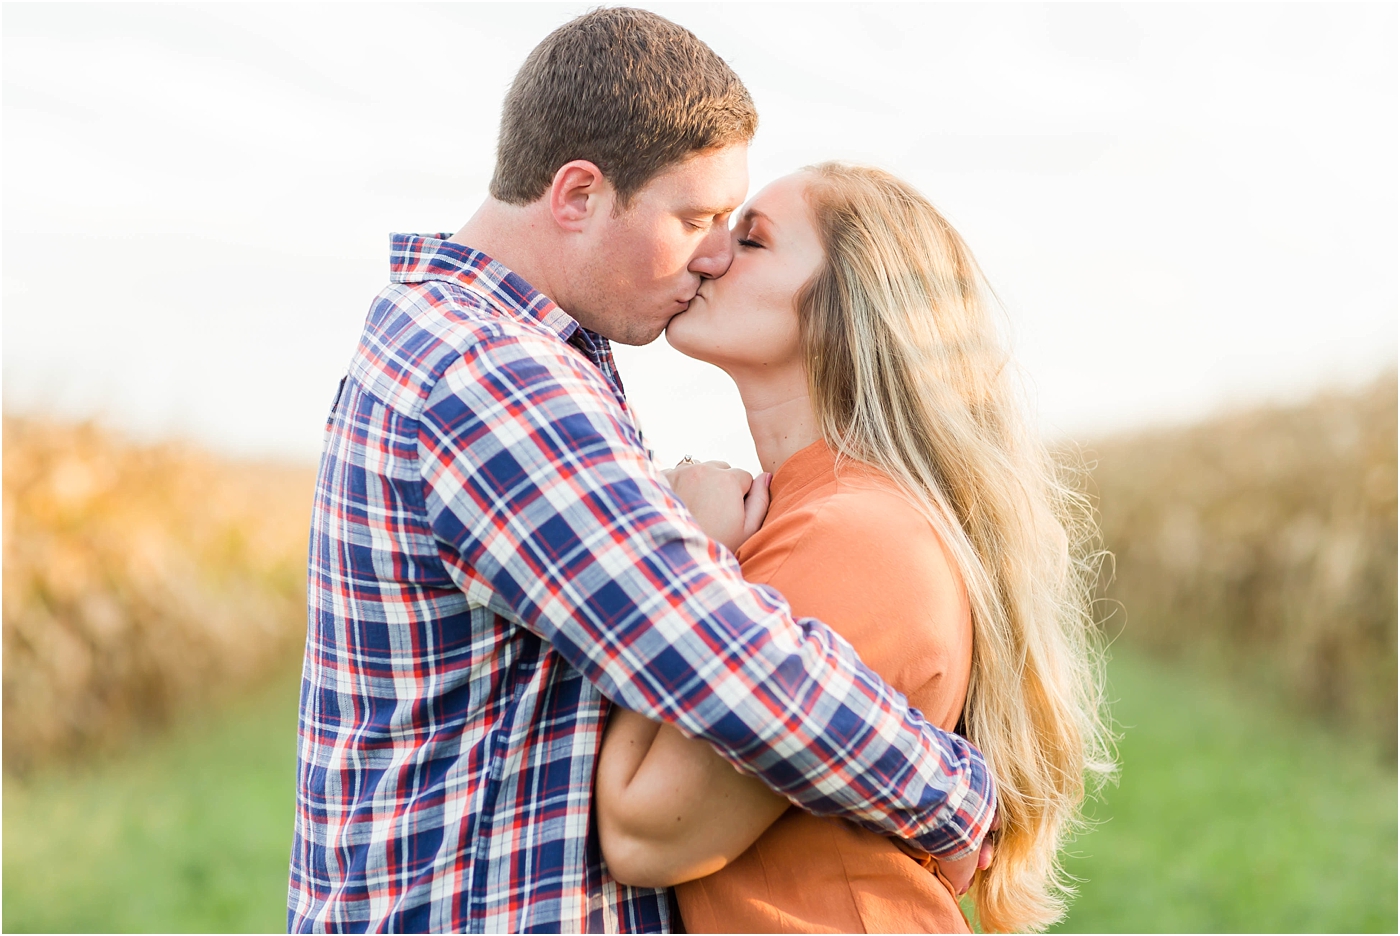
[676,442,972,933]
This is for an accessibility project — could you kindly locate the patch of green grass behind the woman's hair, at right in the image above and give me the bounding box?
[1058,653,1396,933]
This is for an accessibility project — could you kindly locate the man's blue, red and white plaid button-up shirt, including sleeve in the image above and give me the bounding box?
[288,235,993,932]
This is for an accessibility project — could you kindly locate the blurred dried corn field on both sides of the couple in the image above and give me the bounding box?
[4,375,1396,771]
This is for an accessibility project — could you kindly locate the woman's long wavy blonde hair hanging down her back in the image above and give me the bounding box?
[797,162,1114,930]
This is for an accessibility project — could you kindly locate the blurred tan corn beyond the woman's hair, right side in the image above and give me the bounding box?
[1091,372,1396,753]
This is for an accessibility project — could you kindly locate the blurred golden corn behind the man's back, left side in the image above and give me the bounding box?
[3,417,315,771]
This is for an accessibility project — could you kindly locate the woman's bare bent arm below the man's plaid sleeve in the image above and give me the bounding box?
[594,707,788,887]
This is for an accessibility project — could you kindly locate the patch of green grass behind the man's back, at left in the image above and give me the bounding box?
[3,677,297,932]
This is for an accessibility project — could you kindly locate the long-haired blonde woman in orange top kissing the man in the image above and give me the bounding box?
[596,164,1113,932]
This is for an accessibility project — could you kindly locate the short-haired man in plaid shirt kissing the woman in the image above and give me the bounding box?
[288,8,993,932]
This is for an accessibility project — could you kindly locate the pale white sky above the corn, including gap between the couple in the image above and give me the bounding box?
[3,4,1400,467]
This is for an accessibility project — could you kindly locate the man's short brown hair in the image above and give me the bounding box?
[491,7,759,206]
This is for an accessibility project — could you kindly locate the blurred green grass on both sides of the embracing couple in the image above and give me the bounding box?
[3,653,1396,932]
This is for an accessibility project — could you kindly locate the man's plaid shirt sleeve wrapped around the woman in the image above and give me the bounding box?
[419,334,994,858]
